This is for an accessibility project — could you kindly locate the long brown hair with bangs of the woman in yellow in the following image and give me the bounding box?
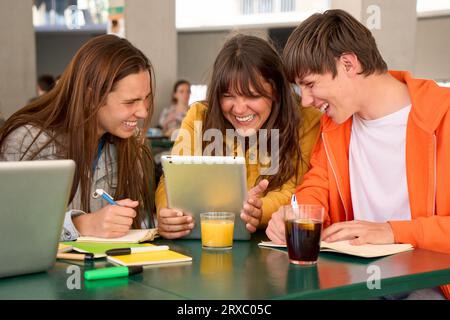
[203,35,302,193]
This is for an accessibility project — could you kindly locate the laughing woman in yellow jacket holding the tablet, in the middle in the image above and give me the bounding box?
[156,35,321,239]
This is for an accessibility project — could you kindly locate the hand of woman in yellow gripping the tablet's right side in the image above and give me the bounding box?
[241,179,269,233]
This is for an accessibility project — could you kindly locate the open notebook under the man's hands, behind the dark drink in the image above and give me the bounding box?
[258,240,414,258]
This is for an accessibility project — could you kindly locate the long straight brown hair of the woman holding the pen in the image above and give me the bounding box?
[0,35,155,228]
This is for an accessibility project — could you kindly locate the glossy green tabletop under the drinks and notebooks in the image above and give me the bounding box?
[0,233,450,300]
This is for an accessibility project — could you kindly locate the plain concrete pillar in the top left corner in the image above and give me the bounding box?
[0,0,36,117]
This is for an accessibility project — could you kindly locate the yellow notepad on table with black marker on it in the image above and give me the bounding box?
[107,250,192,266]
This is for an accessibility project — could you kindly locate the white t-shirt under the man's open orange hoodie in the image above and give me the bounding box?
[349,105,411,222]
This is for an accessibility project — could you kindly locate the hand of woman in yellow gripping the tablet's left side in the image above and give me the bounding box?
[158,208,195,239]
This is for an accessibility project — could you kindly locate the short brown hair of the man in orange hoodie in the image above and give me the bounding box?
[283,10,387,82]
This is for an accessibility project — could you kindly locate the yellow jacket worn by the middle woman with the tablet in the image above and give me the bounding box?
[156,102,321,228]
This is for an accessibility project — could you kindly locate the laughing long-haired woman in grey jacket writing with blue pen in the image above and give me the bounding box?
[0,35,154,240]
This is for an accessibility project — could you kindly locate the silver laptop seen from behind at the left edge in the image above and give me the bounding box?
[0,160,75,277]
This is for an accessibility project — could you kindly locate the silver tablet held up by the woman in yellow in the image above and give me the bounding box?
[161,155,250,240]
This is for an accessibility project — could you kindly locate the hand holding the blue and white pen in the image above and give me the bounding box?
[73,199,139,238]
